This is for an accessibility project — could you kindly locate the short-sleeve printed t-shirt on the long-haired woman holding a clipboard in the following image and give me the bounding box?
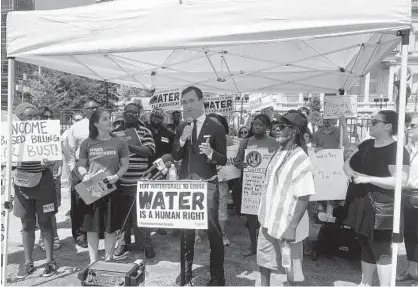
[80,137,129,175]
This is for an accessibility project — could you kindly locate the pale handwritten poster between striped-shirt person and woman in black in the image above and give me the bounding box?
[309,149,348,201]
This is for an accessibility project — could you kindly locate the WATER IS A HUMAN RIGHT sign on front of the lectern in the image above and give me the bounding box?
[136,180,208,229]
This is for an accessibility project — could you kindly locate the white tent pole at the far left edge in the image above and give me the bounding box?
[1,58,15,286]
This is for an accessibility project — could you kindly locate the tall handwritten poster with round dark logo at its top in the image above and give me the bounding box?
[241,148,272,215]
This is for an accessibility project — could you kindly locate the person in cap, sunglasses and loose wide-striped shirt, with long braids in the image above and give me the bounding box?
[257,111,315,286]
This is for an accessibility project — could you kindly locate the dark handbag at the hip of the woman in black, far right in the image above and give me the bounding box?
[367,191,395,230]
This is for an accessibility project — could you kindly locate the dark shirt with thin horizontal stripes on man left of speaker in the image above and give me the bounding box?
[114,122,155,186]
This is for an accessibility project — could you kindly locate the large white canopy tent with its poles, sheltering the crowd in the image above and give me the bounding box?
[3,0,411,284]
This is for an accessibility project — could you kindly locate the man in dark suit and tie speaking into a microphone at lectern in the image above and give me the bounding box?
[172,86,226,286]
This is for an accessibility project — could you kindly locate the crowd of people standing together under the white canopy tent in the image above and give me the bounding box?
[4,87,418,286]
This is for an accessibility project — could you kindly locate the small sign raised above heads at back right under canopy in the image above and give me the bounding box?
[324,96,357,119]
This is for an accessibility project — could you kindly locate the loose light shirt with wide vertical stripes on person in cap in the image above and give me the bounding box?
[258,147,315,242]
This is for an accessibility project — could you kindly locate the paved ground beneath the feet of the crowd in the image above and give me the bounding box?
[0,188,412,286]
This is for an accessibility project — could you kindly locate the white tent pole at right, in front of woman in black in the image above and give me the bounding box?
[390,29,409,286]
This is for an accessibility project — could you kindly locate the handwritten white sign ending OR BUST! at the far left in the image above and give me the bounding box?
[1,120,62,163]
